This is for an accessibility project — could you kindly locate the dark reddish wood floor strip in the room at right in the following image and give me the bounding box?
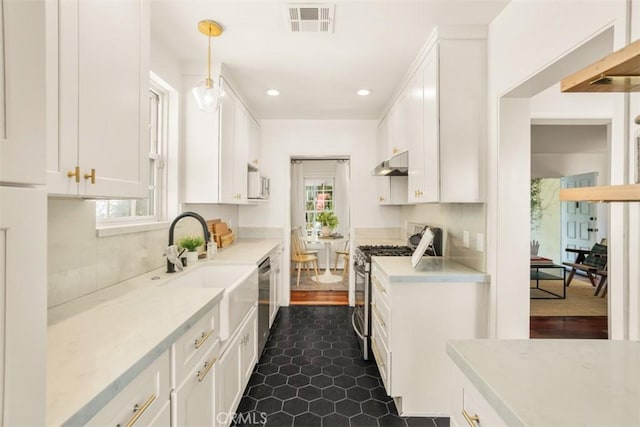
[529,316,609,339]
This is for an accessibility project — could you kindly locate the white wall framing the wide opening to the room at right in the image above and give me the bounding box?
[487,0,626,338]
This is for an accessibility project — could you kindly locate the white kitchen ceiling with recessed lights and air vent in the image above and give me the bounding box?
[151,0,508,119]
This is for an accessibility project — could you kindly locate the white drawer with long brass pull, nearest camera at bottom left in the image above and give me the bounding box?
[87,350,171,426]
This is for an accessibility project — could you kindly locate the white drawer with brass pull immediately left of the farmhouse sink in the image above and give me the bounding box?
[175,305,219,386]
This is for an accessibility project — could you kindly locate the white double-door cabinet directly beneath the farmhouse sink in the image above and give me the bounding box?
[216,307,258,426]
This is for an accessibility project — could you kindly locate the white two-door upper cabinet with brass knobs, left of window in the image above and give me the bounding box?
[47,0,150,198]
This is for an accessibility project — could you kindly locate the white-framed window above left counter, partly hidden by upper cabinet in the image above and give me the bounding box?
[96,89,163,225]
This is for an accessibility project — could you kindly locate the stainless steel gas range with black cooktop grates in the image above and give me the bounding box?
[351,227,442,360]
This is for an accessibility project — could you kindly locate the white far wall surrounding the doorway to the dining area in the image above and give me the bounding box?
[239,120,400,305]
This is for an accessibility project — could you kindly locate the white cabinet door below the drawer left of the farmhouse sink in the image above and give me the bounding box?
[175,351,217,427]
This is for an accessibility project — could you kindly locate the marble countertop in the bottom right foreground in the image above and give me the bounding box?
[446,339,640,427]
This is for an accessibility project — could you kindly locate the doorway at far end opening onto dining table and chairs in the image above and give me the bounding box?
[289,157,351,305]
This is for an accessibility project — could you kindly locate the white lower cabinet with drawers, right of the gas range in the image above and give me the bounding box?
[371,257,486,416]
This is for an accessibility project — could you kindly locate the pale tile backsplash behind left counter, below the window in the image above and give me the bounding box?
[47,198,168,307]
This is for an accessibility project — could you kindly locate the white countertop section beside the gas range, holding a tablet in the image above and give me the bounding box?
[371,256,489,283]
